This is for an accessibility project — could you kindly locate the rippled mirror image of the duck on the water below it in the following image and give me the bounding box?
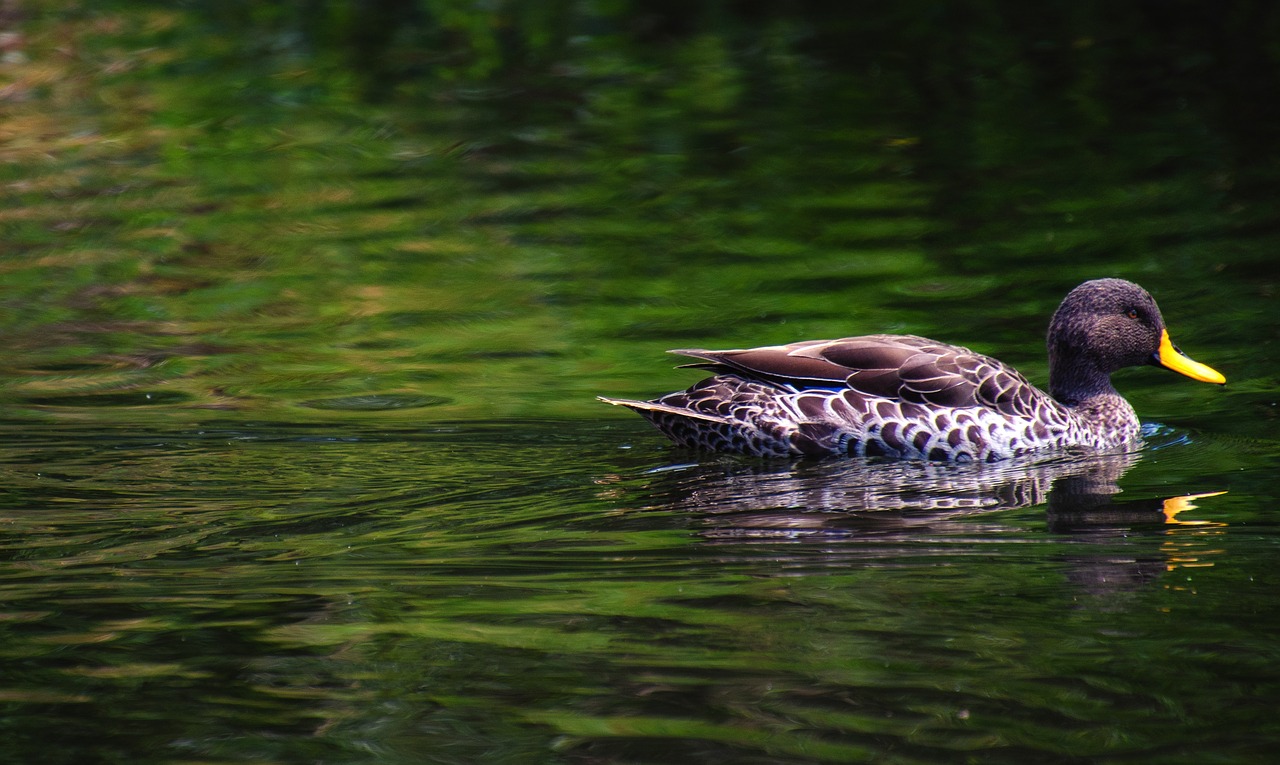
[622,452,1222,590]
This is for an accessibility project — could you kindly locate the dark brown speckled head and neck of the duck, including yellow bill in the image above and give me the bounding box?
[1048,279,1226,403]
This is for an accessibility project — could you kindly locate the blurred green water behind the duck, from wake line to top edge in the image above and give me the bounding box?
[0,0,1280,432]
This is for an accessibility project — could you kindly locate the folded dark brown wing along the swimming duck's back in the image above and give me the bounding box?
[672,335,1052,417]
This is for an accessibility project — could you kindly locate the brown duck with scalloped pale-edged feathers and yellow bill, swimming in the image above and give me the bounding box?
[598,279,1226,462]
